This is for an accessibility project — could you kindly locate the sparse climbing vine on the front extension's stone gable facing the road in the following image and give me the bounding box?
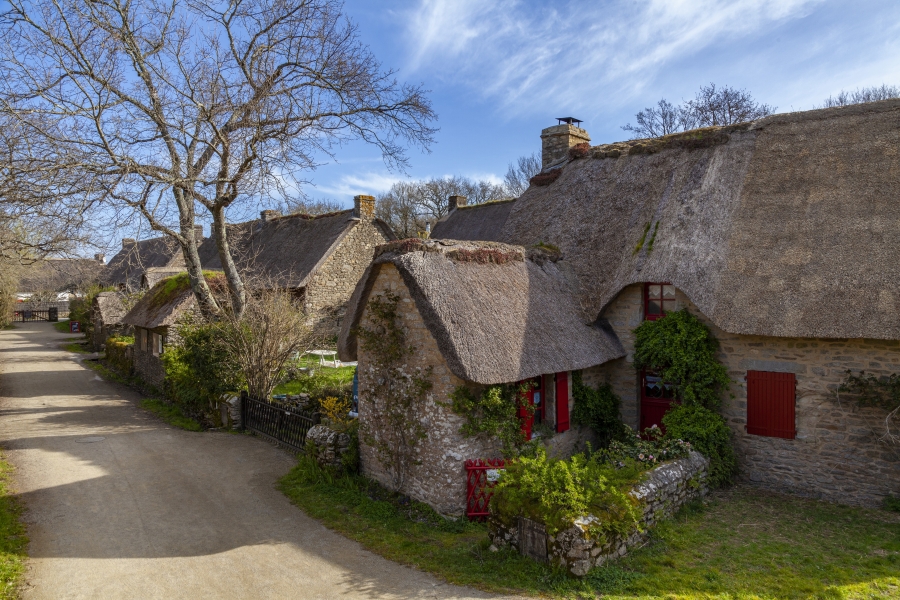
[356,291,432,491]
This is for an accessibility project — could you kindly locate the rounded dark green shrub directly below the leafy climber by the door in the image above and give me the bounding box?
[663,404,737,485]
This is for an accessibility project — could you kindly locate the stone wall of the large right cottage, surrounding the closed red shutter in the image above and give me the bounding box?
[585,285,900,506]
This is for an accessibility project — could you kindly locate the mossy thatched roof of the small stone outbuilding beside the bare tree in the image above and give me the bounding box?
[122,271,225,329]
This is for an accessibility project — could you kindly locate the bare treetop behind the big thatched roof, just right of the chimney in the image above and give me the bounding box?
[622,83,775,138]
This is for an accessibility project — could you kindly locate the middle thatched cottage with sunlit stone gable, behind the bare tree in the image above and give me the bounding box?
[200,196,396,335]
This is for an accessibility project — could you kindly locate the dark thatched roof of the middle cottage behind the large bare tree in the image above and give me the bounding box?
[200,209,396,289]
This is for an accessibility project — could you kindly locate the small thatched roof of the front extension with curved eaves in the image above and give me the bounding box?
[338,240,625,384]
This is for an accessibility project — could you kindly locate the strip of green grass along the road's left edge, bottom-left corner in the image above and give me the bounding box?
[0,453,28,600]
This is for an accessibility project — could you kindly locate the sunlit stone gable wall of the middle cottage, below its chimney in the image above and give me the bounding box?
[306,220,388,333]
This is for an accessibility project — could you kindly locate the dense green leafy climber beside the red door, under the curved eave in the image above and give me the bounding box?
[634,309,731,410]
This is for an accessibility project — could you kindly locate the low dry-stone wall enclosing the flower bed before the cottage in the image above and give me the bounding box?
[488,452,709,577]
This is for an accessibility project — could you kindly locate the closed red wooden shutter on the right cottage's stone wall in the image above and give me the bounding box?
[747,371,797,440]
